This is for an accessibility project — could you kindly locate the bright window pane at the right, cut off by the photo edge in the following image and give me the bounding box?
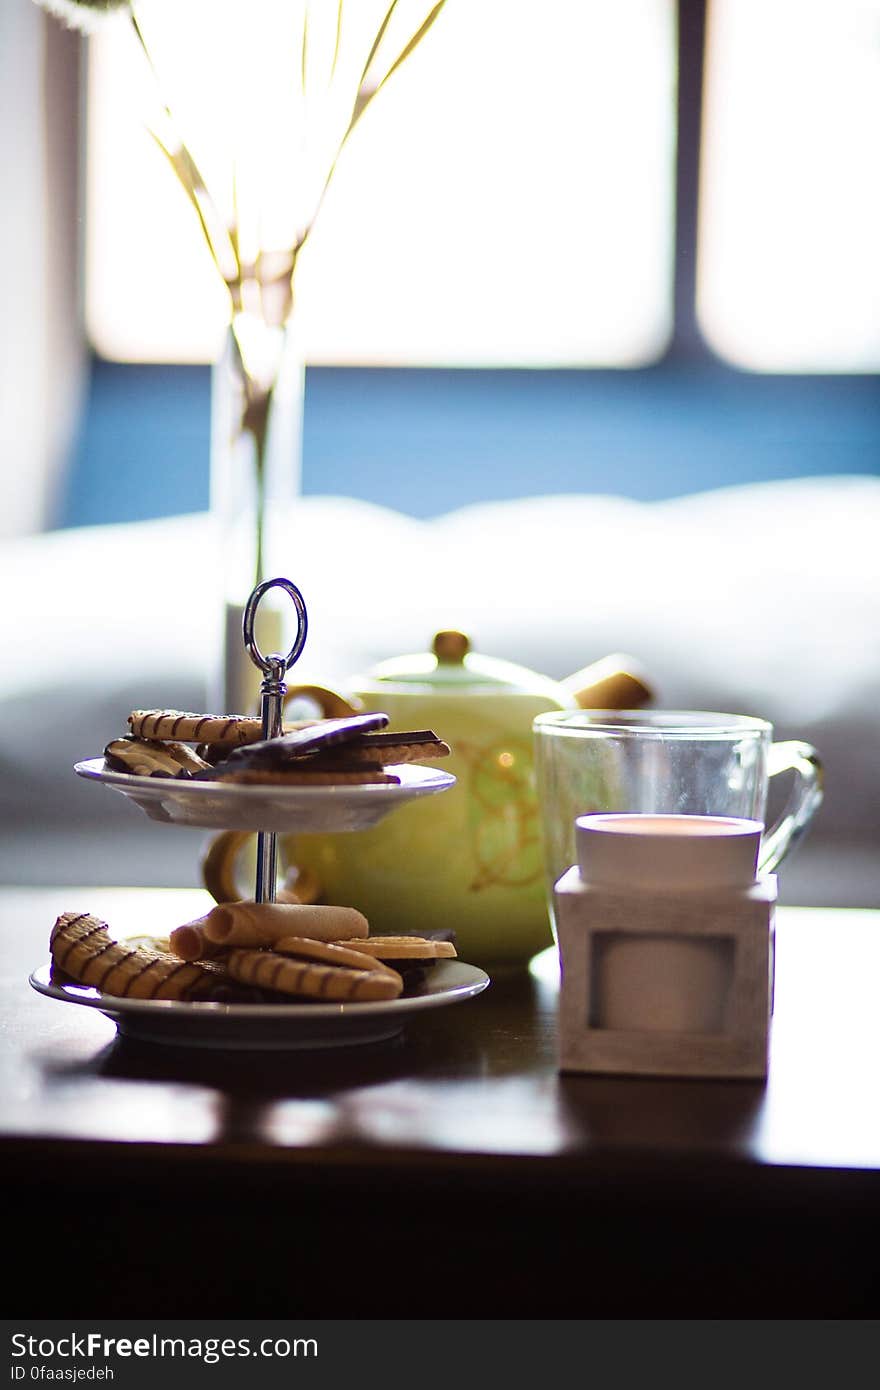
[696,0,880,373]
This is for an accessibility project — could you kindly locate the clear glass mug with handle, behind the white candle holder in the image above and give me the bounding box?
[532,709,822,934]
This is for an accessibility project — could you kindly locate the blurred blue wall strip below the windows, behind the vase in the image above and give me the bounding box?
[57,360,880,527]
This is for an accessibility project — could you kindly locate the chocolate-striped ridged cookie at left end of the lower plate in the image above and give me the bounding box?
[49,912,225,999]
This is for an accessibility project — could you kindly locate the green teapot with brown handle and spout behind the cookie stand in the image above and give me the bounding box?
[206,631,651,969]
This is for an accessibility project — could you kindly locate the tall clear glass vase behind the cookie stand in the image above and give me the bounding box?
[210,324,304,713]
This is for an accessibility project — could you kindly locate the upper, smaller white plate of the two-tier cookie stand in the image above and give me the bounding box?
[74,758,455,834]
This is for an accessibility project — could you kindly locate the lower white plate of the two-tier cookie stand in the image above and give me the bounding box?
[29,960,489,1051]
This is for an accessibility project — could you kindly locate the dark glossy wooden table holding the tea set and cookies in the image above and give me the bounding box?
[0,888,880,1318]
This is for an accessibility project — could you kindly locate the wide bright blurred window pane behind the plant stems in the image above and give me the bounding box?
[86,0,676,367]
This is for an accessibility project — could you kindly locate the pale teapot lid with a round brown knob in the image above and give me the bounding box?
[370,628,557,699]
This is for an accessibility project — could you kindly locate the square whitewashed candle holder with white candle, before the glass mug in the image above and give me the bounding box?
[555,815,776,1079]
